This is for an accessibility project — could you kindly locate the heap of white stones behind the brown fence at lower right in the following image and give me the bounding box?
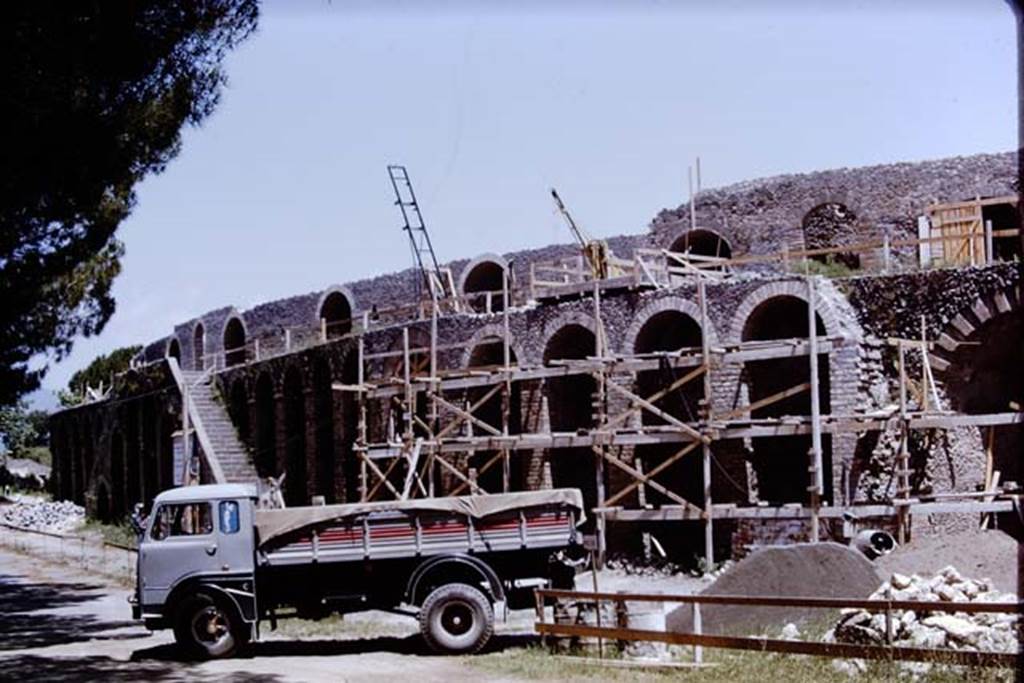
[822,566,1020,669]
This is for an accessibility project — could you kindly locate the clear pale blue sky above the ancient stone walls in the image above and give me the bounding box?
[36,0,1017,405]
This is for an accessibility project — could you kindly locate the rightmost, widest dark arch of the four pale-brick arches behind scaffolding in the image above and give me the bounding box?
[742,295,831,505]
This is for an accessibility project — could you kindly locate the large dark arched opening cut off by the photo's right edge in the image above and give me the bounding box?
[943,310,1024,538]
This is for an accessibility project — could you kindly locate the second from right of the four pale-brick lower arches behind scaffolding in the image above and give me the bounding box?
[635,310,703,507]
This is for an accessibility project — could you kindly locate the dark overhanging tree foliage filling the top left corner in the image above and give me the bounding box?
[0,0,258,405]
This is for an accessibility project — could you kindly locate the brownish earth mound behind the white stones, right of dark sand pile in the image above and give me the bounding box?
[874,529,1021,593]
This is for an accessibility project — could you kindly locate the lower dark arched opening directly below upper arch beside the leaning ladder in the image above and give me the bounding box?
[466,337,525,494]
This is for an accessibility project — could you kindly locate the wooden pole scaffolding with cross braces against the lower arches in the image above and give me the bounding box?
[334,260,1024,566]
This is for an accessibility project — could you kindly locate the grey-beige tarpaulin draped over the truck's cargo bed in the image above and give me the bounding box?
[256,488,586,544]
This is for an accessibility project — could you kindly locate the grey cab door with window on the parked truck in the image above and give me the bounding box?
[138,501,219,609]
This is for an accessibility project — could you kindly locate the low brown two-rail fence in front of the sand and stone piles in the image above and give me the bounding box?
[535,589,1024,667]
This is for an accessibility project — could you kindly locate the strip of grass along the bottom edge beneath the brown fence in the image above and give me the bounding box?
[465,647,1013,683]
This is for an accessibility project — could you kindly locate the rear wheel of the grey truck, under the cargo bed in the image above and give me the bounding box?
[420,584,495,654]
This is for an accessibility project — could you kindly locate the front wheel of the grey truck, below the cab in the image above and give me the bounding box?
[174,593,248,659]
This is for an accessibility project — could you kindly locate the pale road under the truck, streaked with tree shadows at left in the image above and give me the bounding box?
[0,548,524,683]
